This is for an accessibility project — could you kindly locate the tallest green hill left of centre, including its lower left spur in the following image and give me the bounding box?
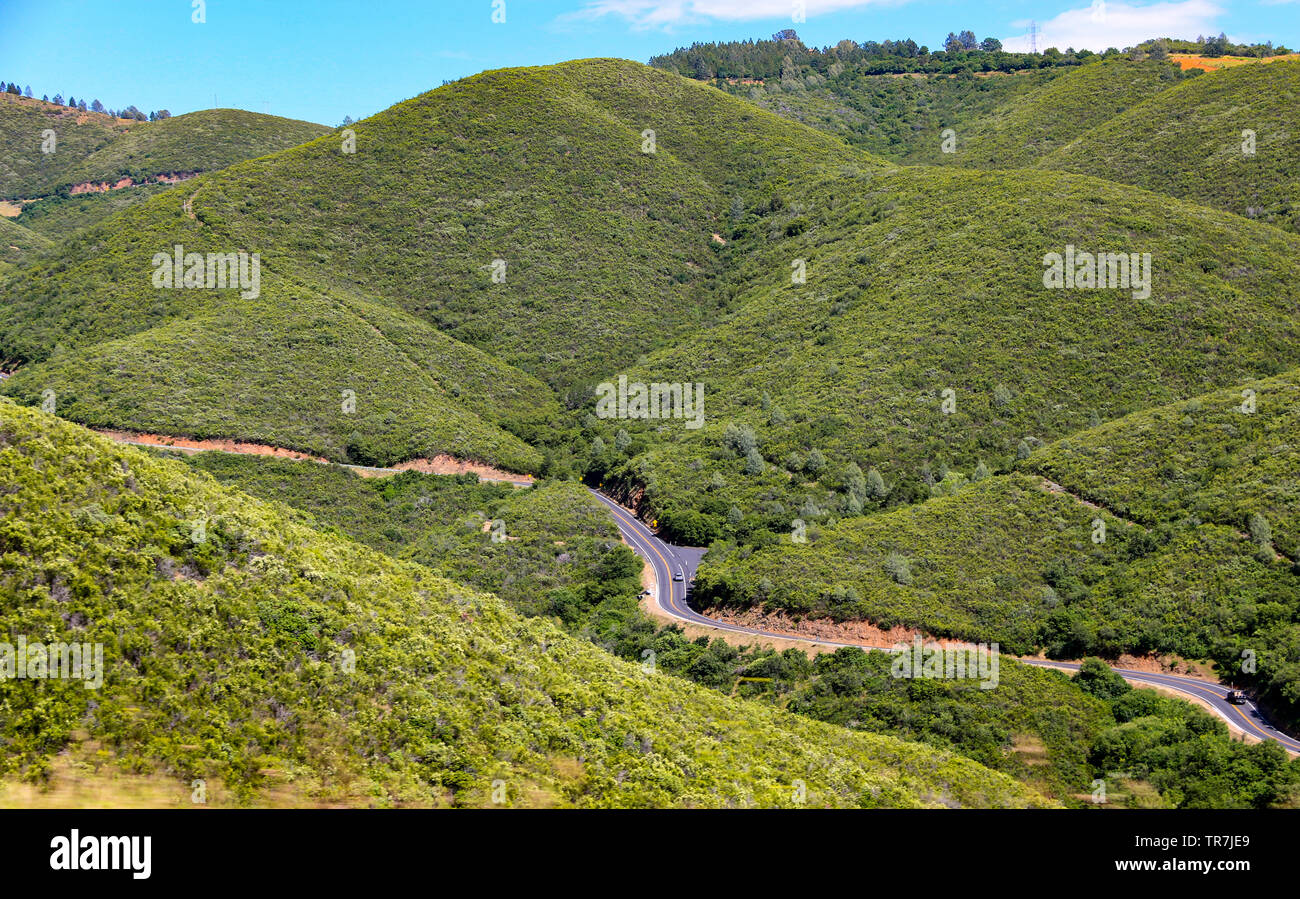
[0,60,881,470]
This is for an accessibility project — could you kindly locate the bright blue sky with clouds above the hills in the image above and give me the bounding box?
[0,0,1300,125]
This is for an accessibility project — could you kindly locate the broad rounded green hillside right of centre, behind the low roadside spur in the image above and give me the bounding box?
[602,169,1300,533]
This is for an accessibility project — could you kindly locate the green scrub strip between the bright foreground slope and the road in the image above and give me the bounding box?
[167,444,1300,807]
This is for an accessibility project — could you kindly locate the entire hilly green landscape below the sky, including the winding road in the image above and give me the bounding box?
[0,36,1300,808]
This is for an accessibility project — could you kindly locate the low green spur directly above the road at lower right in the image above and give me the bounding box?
[697,373,1300,722]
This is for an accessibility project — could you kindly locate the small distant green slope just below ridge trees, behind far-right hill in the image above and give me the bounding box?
[909,58,1184,174]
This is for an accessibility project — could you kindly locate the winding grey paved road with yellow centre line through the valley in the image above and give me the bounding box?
[592,490,1300,753]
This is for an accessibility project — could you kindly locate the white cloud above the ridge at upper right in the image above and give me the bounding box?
[1002,0,1223,52]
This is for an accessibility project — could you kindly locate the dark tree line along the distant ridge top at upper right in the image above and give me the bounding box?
[650,29,1290,81]
